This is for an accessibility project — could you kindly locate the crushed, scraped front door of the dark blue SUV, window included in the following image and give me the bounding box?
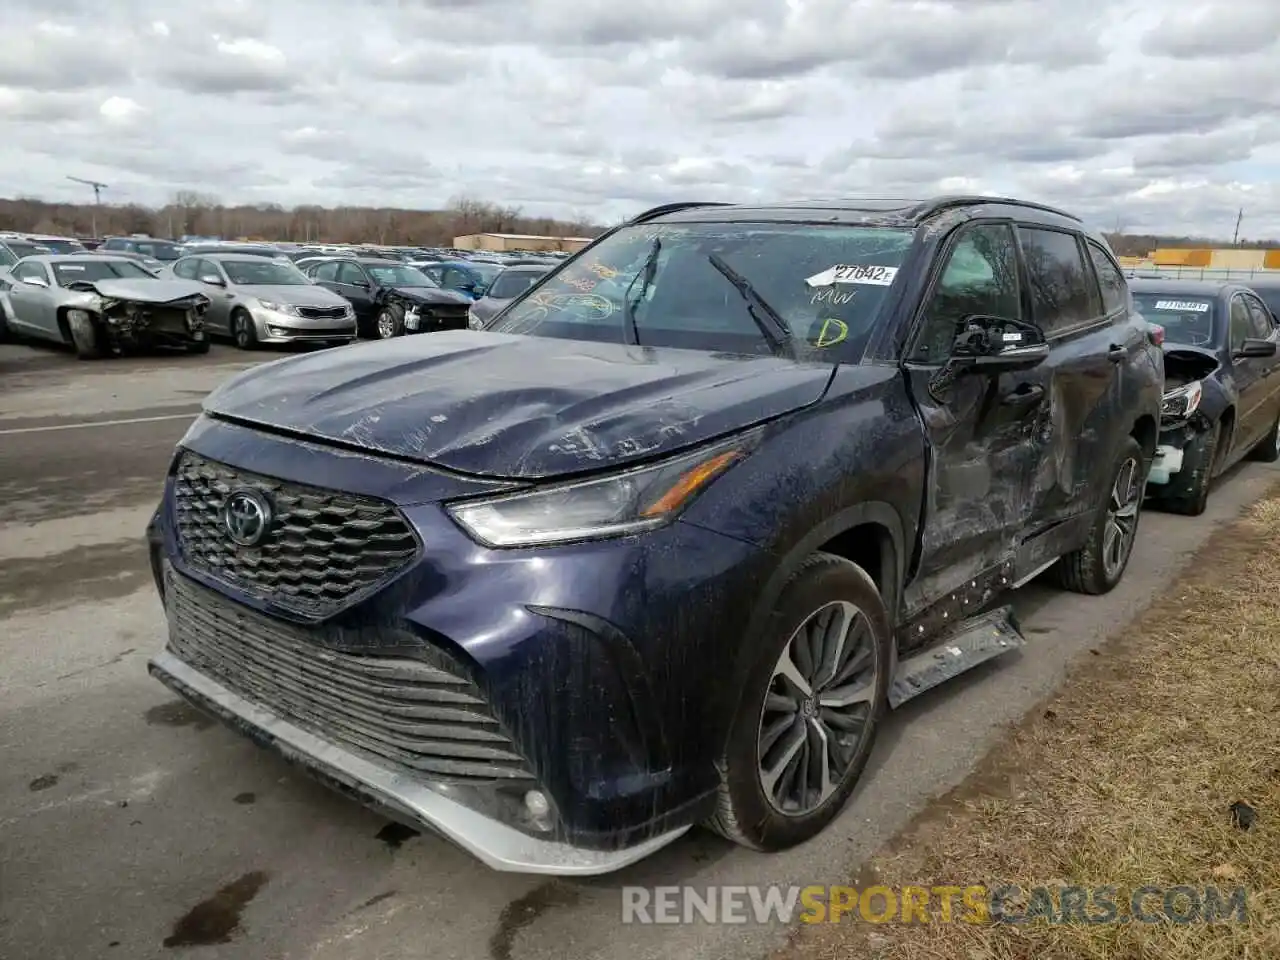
[904,221,1052,618]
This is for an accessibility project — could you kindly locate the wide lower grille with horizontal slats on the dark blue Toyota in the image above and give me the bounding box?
[165,568,532,783]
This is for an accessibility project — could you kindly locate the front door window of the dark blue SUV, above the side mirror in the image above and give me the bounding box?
[910,224,1023,364]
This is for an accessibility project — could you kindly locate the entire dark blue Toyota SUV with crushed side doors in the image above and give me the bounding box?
[148,197,1164,874]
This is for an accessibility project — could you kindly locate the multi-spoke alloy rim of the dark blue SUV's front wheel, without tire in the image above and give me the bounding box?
[756,600,881,817]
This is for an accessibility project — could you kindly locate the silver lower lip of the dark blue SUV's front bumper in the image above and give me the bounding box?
[147,652,689,877]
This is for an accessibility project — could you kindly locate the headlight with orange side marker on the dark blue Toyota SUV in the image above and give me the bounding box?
[448,442,748,547]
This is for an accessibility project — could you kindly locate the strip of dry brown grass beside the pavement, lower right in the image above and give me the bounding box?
[777,495,1280,960]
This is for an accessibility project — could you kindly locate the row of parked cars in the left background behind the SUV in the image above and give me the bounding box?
[0,244,549,358]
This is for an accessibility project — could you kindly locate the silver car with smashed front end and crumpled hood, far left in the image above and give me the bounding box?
[0,253,210,360]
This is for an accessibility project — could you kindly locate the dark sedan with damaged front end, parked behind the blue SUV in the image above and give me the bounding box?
[1129,278,1280,516]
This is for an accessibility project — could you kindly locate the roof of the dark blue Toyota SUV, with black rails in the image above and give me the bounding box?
[640,195,1093,234]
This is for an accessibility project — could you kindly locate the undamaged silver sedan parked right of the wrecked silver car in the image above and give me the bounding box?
[172,253,356,349]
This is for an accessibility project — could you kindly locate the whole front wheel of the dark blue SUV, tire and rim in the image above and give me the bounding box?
[708,553,892,851]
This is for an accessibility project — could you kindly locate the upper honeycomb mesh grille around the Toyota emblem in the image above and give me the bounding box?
[174,451,419,617]
